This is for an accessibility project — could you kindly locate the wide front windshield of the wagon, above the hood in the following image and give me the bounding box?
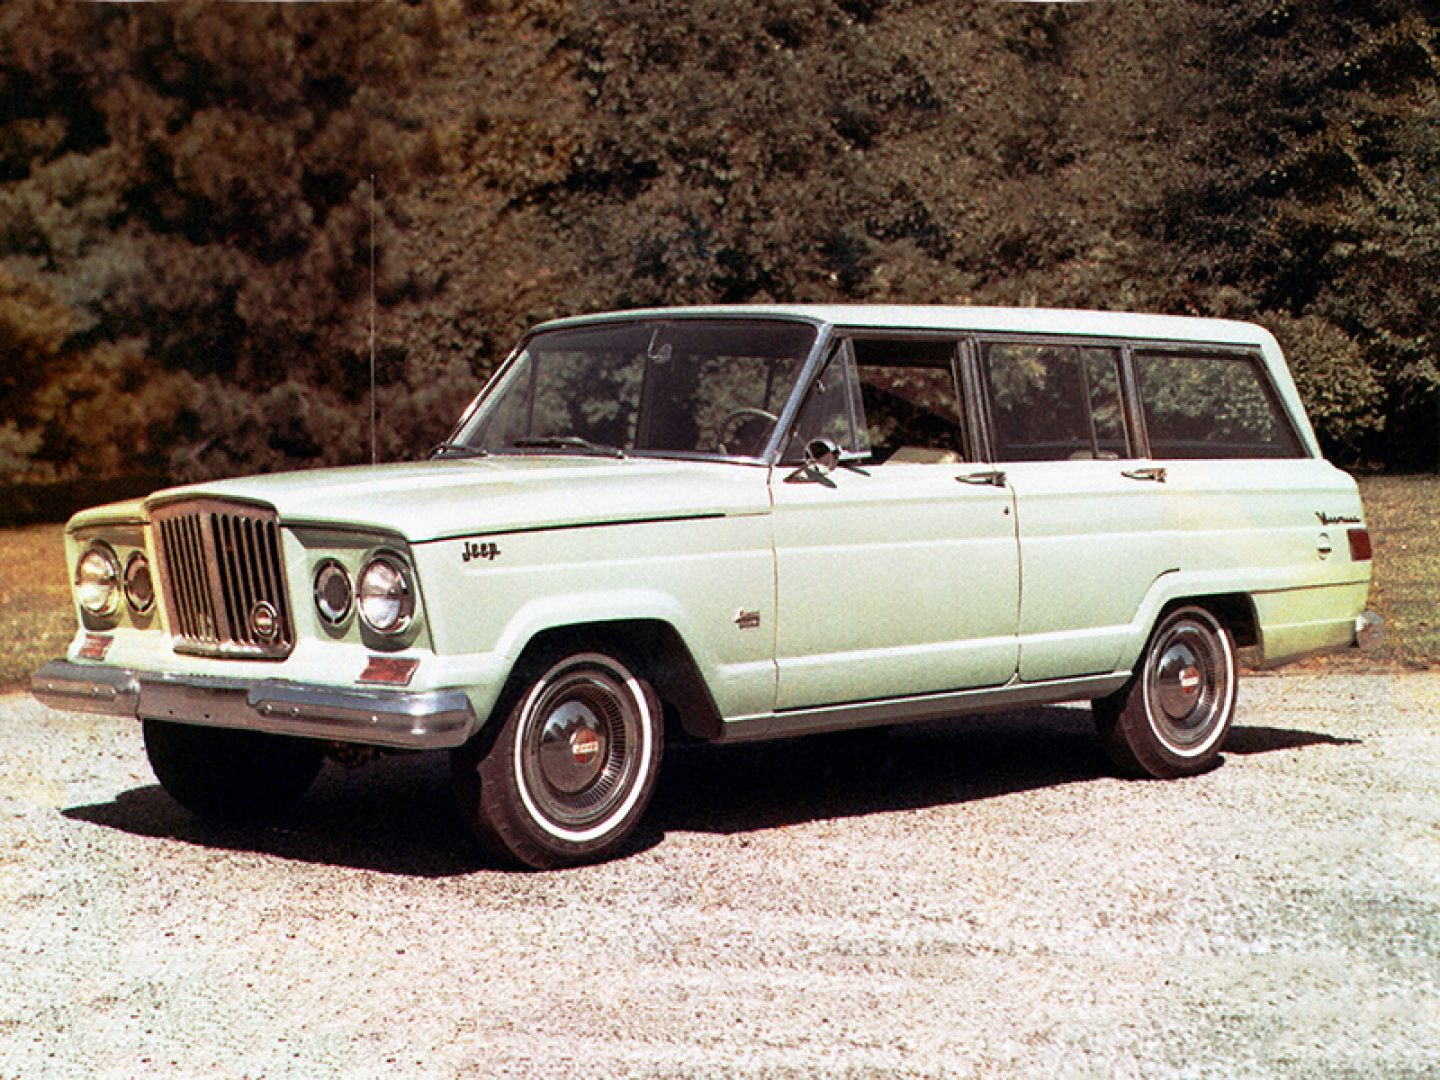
[446,320,816,458]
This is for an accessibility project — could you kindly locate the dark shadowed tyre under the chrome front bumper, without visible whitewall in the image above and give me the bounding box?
[144,720,324,822]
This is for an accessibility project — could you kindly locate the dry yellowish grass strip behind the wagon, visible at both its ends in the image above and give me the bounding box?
[0,477,1440,690]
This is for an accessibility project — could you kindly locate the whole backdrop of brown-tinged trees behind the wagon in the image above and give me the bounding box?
[0,0,1440,478]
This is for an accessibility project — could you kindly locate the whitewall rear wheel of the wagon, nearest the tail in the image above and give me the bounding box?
[1094,608,1238,779]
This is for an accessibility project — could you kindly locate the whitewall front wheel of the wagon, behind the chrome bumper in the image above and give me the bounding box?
[451,649,664,870]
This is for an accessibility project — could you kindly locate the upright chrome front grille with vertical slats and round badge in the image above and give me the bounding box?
[151,500,295,658]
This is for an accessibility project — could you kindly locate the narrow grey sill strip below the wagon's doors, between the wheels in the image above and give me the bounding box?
[716,671,1130,743]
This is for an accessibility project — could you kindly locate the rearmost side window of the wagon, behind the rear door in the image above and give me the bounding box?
[1135,353,1305,458]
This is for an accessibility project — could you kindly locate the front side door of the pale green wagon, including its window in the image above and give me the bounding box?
[772,337,1020,714]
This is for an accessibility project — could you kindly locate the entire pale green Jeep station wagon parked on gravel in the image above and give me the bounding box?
[33,307,1372,867]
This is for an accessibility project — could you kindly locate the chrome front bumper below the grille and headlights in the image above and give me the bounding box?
[30,660,475,750]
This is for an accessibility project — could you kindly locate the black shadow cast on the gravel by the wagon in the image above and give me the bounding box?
[62,706,1355,878]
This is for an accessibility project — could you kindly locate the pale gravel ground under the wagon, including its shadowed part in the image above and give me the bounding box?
[0,672,1440,1077]
